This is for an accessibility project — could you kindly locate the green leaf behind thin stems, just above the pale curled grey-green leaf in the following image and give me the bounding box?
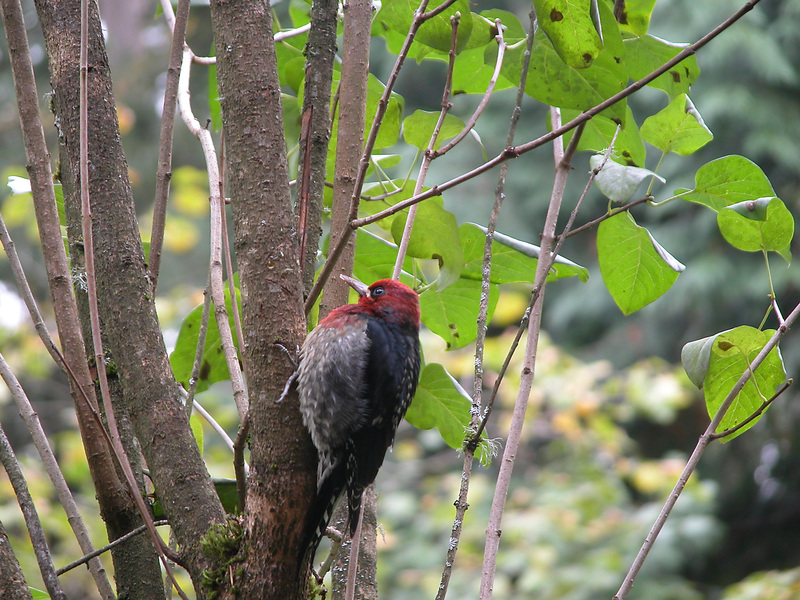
[560,107,646,167]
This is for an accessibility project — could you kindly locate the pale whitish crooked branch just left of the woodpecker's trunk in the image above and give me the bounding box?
[178,48,248,418]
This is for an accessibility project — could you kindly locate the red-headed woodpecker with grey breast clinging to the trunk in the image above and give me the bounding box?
[297,275,420,559]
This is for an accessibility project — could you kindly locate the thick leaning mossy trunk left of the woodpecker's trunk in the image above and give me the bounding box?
[31,0,225,597]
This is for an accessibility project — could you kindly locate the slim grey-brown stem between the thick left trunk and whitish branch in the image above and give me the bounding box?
[147,0,191,293]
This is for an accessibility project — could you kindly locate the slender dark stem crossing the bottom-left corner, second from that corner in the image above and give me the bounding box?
[0,408,67,600]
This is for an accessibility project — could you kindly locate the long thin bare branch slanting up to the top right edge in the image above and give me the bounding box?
[354,0,761,230]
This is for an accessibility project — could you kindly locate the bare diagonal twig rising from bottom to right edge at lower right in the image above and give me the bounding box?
[613,304,800,600]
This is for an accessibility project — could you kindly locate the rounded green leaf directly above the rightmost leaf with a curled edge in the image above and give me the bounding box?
[675,154,775,212]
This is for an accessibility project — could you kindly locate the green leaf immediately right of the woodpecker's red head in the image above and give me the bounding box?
[419,279,499,350]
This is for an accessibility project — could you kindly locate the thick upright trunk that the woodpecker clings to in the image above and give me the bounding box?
[211,0,316,599]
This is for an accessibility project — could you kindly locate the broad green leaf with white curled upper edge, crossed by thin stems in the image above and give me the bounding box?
[459,223,589,284]
